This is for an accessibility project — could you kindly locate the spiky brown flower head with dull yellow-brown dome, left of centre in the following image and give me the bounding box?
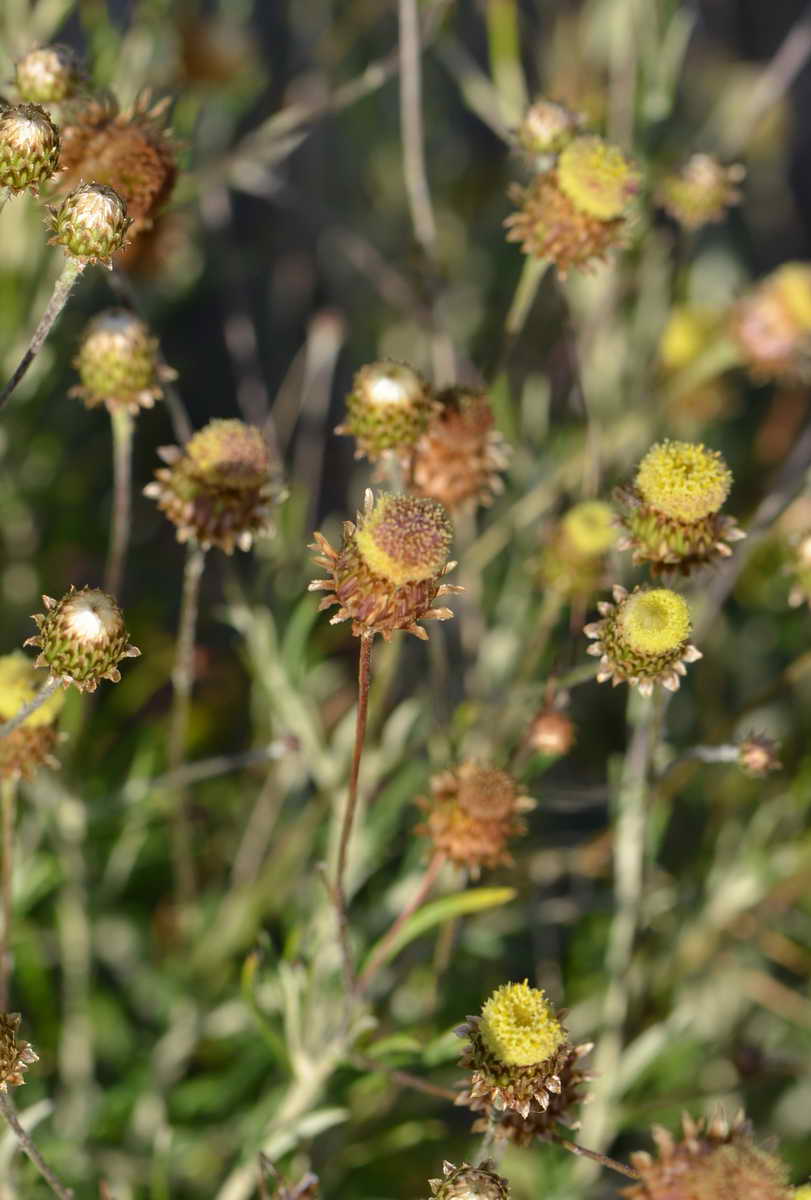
[144,420,281,554]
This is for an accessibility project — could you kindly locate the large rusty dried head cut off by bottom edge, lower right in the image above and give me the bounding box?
[624,1114,791,1200]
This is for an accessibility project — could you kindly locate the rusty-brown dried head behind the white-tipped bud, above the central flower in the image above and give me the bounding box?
[411,388,507,512]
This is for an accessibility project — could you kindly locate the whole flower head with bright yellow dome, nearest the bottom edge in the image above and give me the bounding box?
[456,980,572,1120]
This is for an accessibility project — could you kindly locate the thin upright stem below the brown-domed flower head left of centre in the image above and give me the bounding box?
[168,542,205,906]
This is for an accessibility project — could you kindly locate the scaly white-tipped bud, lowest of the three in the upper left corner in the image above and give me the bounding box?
[50,182,132,265]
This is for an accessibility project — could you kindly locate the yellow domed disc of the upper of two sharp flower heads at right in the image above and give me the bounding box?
[636,442,732,522]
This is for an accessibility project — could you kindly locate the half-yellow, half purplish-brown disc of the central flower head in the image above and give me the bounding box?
[355,492,453,587]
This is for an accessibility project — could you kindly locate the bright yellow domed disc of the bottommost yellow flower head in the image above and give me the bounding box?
[480,979,566,1067]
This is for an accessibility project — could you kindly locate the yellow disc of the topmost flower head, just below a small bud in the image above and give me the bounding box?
[558,134,639,221]
